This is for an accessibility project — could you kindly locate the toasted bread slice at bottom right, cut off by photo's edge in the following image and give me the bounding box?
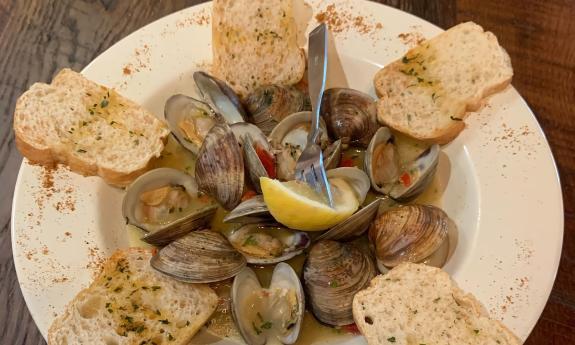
[353,263,521,345]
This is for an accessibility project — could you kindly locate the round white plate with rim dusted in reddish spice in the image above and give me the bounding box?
[12,1,563,339]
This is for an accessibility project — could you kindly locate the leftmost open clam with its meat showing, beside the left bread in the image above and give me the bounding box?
[122,168,217,245]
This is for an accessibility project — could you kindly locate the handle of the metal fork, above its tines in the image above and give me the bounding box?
[308,23,328,143]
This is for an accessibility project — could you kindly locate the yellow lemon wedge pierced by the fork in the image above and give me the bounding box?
[260,177,359,231]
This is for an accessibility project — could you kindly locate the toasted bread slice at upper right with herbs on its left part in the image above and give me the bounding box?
[374,22,513,144]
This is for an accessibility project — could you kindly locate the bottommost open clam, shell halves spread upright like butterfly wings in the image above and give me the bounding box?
[232,263,305,345]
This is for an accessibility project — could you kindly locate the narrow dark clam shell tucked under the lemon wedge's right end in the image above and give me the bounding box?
[316,199,382,241]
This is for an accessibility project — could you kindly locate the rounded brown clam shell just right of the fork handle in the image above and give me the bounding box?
[321,88,379,147]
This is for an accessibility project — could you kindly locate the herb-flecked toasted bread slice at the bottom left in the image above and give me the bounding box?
[48,248,218,345]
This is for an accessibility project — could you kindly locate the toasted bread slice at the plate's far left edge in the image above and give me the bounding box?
[14,69,170,186]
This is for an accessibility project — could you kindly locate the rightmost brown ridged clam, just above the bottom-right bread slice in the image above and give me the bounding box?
[369,205,455,271]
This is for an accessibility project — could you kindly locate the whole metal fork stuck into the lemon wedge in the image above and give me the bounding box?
[295,24,333,207]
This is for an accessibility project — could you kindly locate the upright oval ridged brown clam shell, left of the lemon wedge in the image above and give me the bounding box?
[196,124,244,210]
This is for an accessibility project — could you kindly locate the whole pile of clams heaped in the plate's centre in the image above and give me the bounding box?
[122,72,455,345]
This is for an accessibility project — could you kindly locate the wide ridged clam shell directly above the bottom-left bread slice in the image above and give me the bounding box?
[150,230,246,283]
